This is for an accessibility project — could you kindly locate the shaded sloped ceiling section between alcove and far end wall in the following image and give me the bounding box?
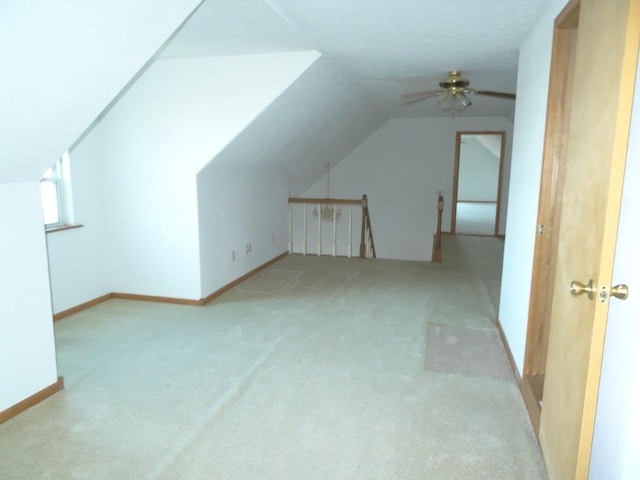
[202,57,387,196]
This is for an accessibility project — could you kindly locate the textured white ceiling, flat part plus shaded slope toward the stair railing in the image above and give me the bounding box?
[178,0,547,196]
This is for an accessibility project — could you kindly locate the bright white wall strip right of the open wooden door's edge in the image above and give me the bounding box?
[589,52,640,480]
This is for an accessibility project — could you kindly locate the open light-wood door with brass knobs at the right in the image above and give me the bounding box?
[539,0,640,480]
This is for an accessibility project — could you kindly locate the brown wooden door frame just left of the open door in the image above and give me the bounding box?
[521,0,580,433]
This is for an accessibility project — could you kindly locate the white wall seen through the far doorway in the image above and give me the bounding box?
[458,137,506,202]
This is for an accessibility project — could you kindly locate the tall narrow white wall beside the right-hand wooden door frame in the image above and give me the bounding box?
[499,0,566,373]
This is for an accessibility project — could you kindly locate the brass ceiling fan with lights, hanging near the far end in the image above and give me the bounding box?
[400,70,516,115]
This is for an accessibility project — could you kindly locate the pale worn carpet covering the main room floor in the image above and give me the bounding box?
[0,236,546,480]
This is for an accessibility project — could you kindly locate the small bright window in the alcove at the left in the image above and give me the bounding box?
[40,152,73,229]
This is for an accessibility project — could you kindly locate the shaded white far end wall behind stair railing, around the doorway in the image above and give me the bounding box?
[297,117,513,261]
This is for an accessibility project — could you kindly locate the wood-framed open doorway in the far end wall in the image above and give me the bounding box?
[451,132,506,236]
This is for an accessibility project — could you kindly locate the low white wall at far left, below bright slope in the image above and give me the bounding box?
[0,182,57,412]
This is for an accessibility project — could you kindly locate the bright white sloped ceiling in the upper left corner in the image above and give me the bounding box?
[0,0,201,183]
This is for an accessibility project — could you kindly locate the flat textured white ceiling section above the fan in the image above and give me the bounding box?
[164,0,548,119]
